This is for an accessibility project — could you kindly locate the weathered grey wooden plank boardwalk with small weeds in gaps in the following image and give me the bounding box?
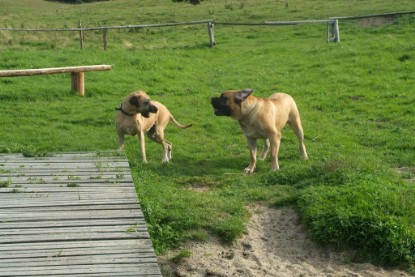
[0,153,161,276]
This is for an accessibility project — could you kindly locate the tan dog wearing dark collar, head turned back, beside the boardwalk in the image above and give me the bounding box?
[115,91,192,163]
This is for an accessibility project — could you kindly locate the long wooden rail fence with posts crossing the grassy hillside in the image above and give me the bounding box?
[0,11,415,50]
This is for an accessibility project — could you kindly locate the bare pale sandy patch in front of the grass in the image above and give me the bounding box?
[160,207,412,277]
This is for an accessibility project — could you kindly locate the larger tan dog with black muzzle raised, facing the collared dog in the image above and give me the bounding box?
[211,89,308,173]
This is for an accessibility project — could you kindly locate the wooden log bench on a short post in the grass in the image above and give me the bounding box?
[0,65,111,96]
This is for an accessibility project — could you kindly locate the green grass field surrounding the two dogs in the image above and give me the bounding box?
[0,0,415,269]
